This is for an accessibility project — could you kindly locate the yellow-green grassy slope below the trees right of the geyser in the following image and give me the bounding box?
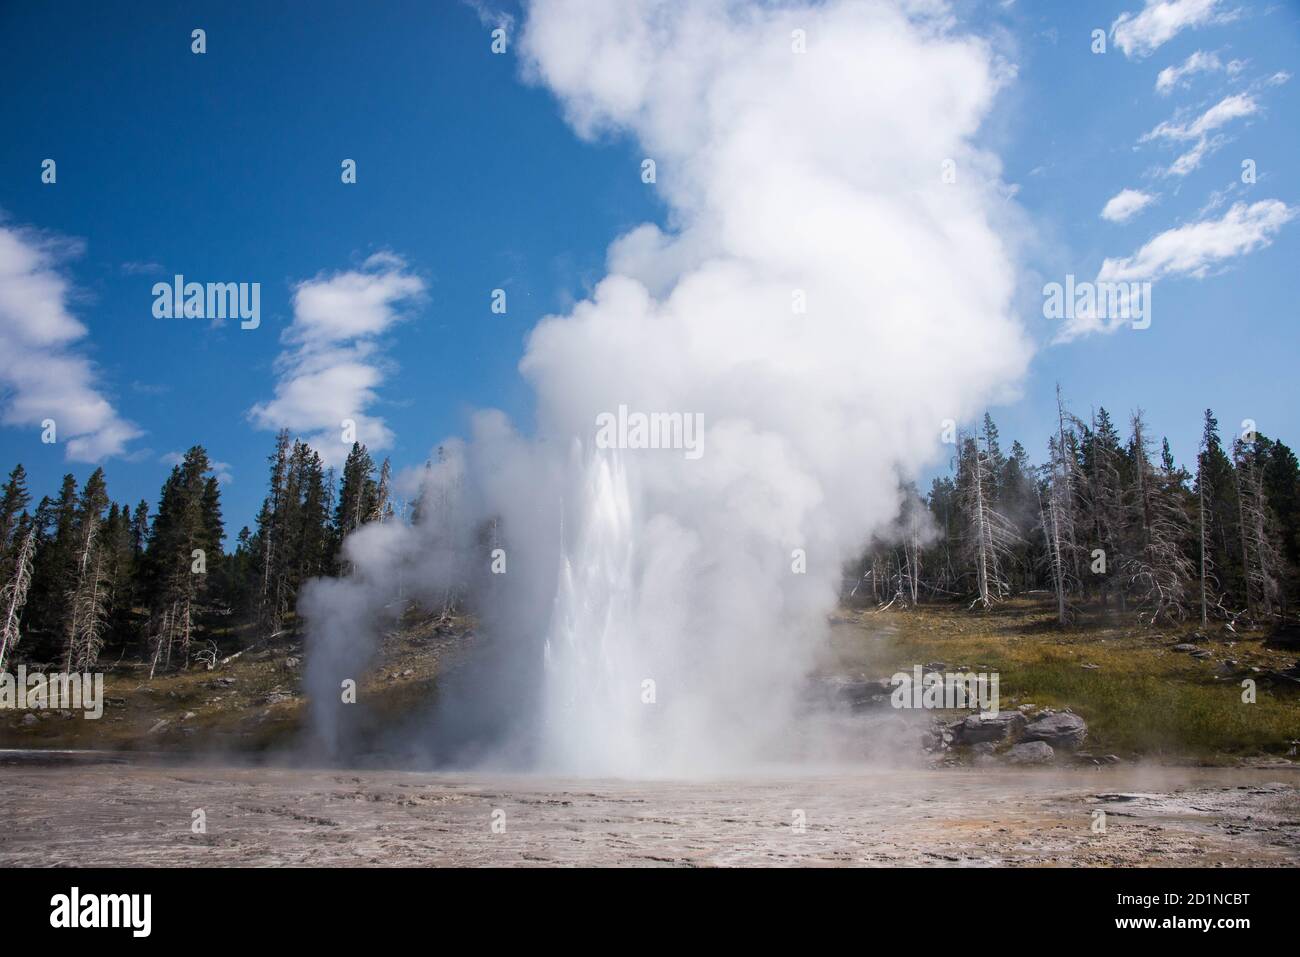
[858,599,1300,762]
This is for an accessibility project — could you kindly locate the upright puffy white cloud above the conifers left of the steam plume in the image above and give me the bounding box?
[248,252,425,464]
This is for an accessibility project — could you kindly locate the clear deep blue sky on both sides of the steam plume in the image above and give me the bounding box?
[0,0,1300,537]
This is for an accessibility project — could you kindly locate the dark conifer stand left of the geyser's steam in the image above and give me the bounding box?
[0,430,395,676]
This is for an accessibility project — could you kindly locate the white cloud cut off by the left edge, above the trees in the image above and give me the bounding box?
[0,226,142,462]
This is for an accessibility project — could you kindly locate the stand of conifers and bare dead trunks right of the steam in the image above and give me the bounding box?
[849,390,1300,628]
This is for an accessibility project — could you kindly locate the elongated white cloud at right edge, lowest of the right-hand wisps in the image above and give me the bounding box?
[1097,199,1300,282]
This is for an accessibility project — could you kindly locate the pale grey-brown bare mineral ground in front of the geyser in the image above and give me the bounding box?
[0,755,1300,867]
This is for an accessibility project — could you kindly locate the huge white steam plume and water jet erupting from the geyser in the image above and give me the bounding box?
[302,0,1030,775]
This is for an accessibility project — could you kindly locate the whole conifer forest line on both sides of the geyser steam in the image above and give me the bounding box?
[0,394,1300,675]
